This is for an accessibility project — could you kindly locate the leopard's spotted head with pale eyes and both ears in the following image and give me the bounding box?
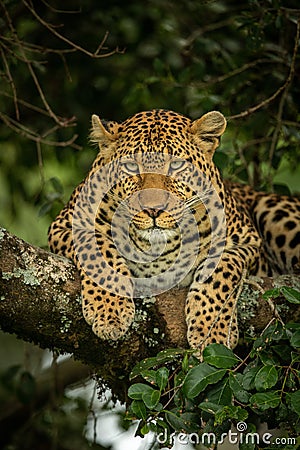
[91,110,226,239]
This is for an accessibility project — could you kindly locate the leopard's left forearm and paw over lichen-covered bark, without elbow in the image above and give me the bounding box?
[77,231,135,340]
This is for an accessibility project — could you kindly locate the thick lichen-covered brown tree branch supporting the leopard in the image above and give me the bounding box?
[0,228,299,397]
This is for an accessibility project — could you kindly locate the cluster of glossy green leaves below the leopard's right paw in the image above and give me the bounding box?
[125,288,300,449]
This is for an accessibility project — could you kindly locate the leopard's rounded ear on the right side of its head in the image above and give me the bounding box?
[190,111,226,155]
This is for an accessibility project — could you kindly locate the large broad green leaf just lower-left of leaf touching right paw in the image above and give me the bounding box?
[182,362,226,398]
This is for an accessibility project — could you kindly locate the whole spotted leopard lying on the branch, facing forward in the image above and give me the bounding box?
[48,109,300,353]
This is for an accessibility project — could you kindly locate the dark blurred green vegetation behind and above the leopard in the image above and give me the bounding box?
[0,0,300,450]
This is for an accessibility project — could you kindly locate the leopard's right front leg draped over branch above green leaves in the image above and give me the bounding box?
[186,250,247,353]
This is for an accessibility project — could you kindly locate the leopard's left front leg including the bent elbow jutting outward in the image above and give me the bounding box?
[49,216,135,340]
